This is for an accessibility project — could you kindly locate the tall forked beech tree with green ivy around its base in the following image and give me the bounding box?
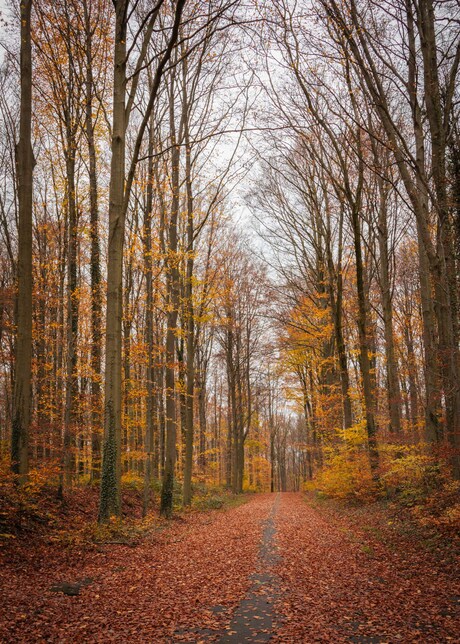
[99,0,186,521]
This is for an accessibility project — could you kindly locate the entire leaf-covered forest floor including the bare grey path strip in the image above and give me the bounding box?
[0,493,460,644]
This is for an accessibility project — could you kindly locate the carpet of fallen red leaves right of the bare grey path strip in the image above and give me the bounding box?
[275,495,460,642]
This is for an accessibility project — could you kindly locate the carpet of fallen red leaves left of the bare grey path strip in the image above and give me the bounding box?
[0,497,270,643]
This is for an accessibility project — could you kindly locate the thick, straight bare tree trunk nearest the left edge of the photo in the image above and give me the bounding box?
[11,0,34,482]
